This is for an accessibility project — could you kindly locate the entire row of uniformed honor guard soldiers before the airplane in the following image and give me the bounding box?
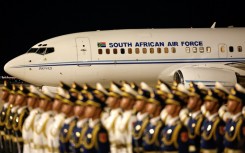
[0,80,245,153]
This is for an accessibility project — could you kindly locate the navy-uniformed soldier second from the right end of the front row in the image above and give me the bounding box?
[200,89,225,153]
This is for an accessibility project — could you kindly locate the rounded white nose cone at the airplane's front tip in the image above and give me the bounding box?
[4,58,25,79]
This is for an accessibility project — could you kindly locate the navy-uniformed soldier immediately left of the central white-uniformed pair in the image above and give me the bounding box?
[81,93,110,153]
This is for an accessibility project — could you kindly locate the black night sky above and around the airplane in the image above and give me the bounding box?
[0,0,245,75]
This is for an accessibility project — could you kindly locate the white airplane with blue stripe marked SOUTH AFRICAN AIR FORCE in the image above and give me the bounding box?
[4,27,245,87]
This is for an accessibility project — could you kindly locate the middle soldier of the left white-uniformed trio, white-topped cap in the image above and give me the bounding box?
[32,87,54,153]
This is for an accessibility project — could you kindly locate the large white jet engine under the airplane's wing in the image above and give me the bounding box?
[174,67,238,88]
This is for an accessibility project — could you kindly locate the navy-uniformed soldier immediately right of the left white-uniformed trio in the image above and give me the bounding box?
[59,93,77,153]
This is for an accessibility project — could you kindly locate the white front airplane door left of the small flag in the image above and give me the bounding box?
[76,38,91,66]
